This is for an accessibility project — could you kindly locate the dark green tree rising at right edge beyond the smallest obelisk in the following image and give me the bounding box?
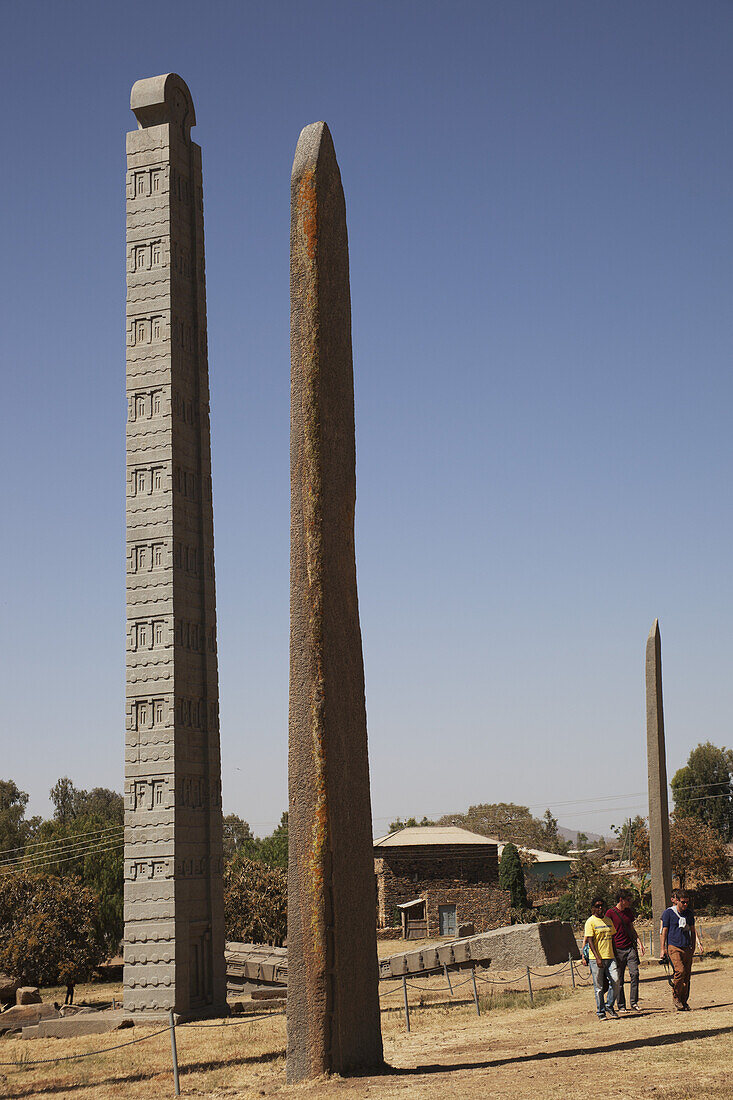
[670,741,733,840]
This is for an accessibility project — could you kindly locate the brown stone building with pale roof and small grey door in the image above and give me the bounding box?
[374,825,510,939]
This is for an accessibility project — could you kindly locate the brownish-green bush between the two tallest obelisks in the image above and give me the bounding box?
[223,855,287,947]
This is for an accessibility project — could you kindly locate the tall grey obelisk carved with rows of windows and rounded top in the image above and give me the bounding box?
[124,73,226,1015]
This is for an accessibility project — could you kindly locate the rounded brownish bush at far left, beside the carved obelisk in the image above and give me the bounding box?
[0,871,106,986]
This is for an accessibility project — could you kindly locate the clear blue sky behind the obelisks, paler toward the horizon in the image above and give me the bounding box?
[0,0,733,833]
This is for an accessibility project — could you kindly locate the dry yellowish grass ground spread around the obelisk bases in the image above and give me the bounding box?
[0,945,733,1100]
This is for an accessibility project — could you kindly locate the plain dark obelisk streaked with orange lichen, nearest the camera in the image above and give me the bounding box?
[287,122,383,1081]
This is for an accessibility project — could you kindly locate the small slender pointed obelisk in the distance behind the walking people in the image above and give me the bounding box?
[646,619,671,948]
